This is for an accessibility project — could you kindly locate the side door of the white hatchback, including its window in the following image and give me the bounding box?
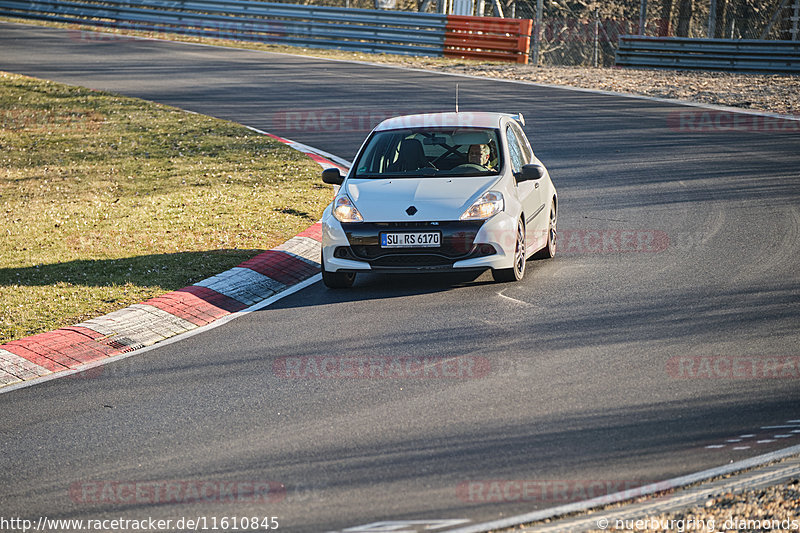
[505,123,545,253]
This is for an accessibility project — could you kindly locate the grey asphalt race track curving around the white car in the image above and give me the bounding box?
[0,23,800,532]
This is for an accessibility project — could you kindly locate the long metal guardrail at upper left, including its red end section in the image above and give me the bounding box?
[0,0,532,63]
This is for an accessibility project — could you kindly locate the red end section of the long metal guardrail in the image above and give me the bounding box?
[444,15,533,63]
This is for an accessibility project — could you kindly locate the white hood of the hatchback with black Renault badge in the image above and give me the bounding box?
[345,175,499,222]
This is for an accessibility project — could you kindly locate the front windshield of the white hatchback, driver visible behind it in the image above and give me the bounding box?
[354,128,502,178]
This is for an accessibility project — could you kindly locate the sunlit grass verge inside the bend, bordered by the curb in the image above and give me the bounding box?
[0,72,332,343]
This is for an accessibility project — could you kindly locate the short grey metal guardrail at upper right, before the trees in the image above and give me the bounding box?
[616,35,800,73]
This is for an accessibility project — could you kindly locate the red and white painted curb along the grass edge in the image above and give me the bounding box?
[0,128,349,388]
